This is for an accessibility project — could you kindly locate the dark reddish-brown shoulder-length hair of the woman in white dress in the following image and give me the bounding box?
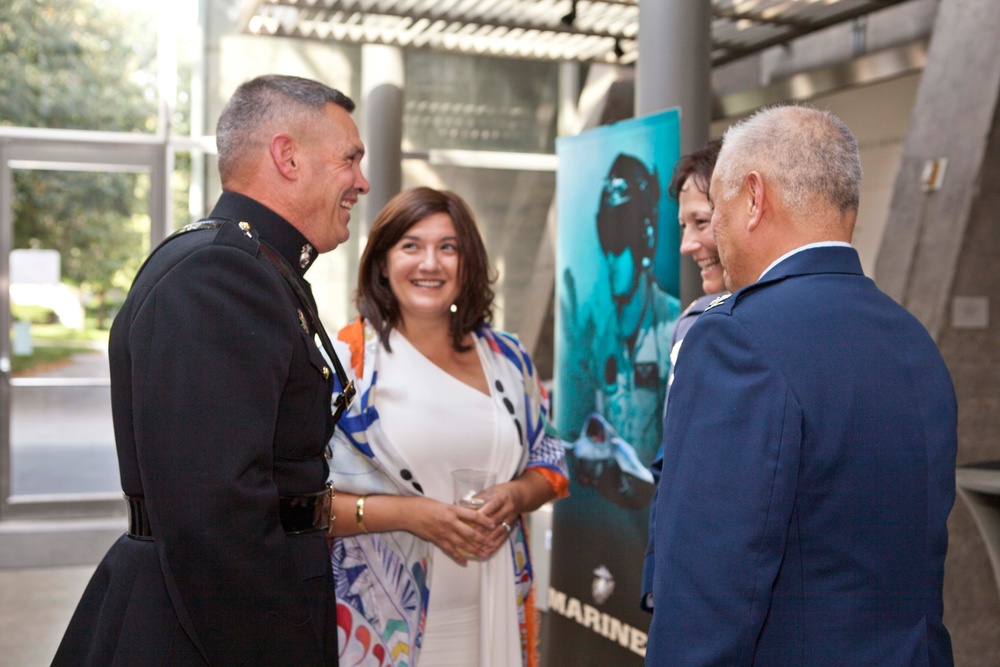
[354,187,496,352]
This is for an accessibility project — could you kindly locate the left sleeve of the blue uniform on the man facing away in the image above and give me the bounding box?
[646,312,803,667]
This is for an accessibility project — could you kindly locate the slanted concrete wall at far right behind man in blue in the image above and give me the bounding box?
[875,0,1000,667]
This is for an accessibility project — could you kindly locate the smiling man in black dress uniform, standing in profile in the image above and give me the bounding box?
[53,76,368,667]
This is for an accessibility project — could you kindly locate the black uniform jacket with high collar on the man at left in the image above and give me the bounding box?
[53,192,337,665]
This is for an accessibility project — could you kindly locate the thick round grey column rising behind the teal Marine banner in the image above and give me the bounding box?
[635,0,712,306]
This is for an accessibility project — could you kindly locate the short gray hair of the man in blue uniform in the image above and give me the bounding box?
[715,105,861,214]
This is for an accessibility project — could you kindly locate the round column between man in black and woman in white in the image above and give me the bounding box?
[360,44,404,230]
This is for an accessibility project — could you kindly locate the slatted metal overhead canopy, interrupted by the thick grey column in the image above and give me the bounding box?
[240,0,906,66]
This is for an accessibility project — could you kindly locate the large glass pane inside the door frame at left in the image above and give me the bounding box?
[10,169,150,495]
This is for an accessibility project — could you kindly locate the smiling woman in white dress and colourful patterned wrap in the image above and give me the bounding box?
[330,188,568,667]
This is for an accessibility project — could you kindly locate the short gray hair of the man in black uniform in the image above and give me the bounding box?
[215,74,354,184]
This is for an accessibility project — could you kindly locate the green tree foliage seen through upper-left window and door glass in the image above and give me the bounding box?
[0,0,157,327]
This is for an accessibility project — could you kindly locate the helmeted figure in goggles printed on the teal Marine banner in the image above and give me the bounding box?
[562,153,679,509]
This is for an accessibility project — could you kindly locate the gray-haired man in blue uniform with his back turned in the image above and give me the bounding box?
[646,107,956,667]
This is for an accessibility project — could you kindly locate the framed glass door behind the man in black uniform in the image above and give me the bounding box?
[0,131,167,518]
